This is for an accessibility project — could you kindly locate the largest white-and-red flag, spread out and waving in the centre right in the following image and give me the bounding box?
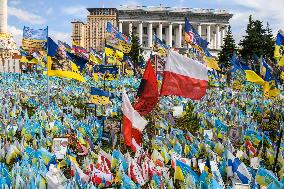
[160,50,208,100]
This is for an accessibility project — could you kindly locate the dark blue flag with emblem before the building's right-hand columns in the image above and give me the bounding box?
[184,18,208,53]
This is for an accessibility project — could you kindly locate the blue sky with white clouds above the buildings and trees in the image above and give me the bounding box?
[8,0,284,44]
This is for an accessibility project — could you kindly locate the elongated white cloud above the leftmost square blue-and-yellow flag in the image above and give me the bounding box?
[8,7,46,24]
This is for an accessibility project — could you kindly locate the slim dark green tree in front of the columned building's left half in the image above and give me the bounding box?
[126,35,143,75]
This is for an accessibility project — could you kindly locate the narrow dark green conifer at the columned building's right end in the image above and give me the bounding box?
[219,26,236,68]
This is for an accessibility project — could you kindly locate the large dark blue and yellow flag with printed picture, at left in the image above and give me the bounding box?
[47,38,85,82]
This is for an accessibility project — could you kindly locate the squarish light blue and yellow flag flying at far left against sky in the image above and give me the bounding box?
[22,26,48,50]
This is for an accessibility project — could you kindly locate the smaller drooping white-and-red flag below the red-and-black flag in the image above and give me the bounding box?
[122,90,148,151]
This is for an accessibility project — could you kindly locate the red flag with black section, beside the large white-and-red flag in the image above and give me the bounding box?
[134,59,159,116]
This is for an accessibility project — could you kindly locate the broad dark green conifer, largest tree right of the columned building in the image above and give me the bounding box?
[240,15,274,60]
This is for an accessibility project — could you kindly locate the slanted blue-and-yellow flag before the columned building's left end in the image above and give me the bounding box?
[106,22,132,53]
